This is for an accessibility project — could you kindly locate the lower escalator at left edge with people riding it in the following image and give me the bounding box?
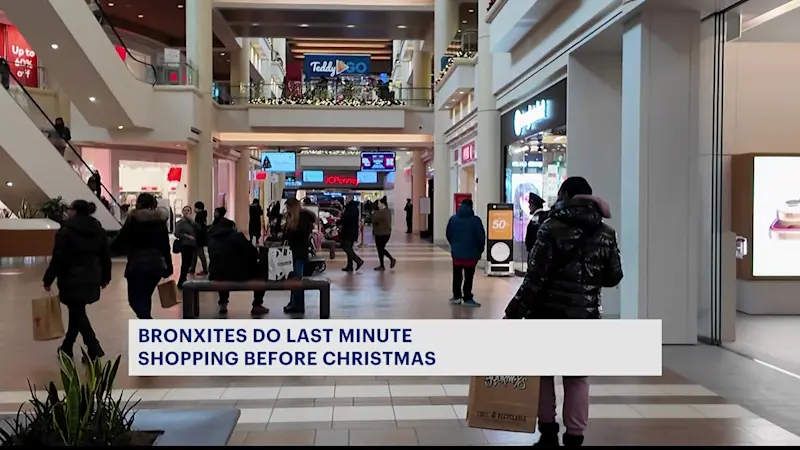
[0,65,122,231]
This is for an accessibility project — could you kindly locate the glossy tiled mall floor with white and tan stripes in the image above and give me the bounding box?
[0,235,800,445]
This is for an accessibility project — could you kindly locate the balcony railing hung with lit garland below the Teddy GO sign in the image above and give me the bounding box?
[212,80,433,107]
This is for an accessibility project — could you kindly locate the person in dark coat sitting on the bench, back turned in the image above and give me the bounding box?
[208,215,269,316]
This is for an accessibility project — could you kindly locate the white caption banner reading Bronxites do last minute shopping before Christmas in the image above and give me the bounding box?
[128,320,662,376]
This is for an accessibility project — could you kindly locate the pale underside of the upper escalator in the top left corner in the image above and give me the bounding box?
[0,0,156,130]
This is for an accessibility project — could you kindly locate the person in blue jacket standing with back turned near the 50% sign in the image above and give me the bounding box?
[447,199,486,307]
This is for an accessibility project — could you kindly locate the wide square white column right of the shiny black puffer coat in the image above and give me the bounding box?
[620,8,700,344]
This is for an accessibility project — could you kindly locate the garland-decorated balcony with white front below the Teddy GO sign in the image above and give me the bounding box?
[213,79,433,134]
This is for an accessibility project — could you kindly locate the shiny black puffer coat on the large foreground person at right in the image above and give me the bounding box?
[506,196,622,319]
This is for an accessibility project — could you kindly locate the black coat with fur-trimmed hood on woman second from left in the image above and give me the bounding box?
[111,208,173,277]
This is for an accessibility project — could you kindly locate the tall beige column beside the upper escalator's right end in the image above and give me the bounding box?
[186,0,215,205]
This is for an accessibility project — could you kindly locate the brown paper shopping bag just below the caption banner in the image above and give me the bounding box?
[467,377,539,433]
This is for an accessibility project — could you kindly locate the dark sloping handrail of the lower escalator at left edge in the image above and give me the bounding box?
[8,65,122,223]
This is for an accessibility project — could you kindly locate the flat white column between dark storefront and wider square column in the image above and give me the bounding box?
[567,51,622,317]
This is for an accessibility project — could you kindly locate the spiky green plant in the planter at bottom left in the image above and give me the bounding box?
[0,352,161,447]
